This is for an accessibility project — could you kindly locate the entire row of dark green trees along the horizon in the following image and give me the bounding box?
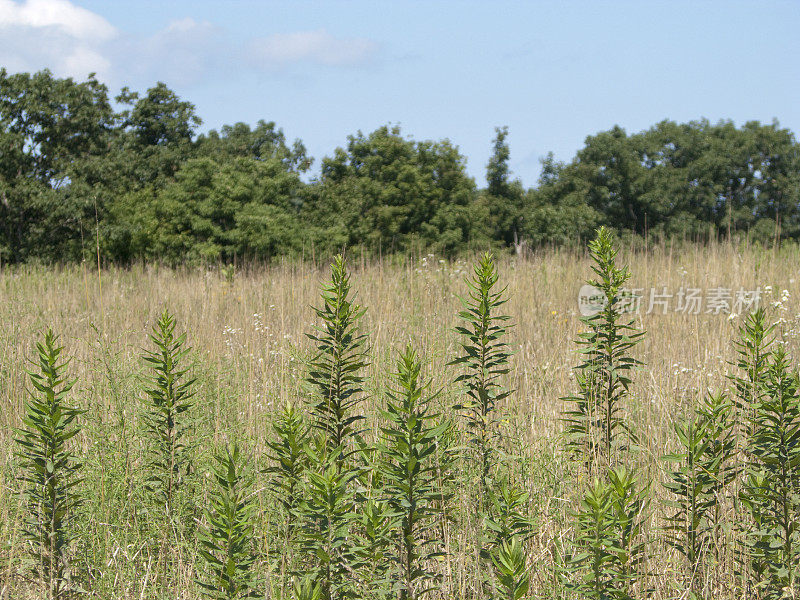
[0,69,800,264]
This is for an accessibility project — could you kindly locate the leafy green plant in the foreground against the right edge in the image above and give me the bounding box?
[741,346,800,598]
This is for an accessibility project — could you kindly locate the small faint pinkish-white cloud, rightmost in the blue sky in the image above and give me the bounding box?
[250,29,378,67]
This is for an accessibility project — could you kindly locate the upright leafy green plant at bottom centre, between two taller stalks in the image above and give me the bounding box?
[378,345,447,600]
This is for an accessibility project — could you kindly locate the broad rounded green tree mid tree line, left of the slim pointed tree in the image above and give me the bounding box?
[304,127,475,253]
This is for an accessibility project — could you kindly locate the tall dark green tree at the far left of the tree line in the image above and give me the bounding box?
[0,69,113,262]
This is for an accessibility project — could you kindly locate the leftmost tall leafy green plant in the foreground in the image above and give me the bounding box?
[16,329,81,600]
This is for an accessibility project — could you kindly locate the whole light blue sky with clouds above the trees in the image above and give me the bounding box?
[0,0,800,187]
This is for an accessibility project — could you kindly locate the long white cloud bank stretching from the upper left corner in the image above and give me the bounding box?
[0,0,378,89]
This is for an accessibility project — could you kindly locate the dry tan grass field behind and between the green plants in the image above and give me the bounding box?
[0,244,800,600]
